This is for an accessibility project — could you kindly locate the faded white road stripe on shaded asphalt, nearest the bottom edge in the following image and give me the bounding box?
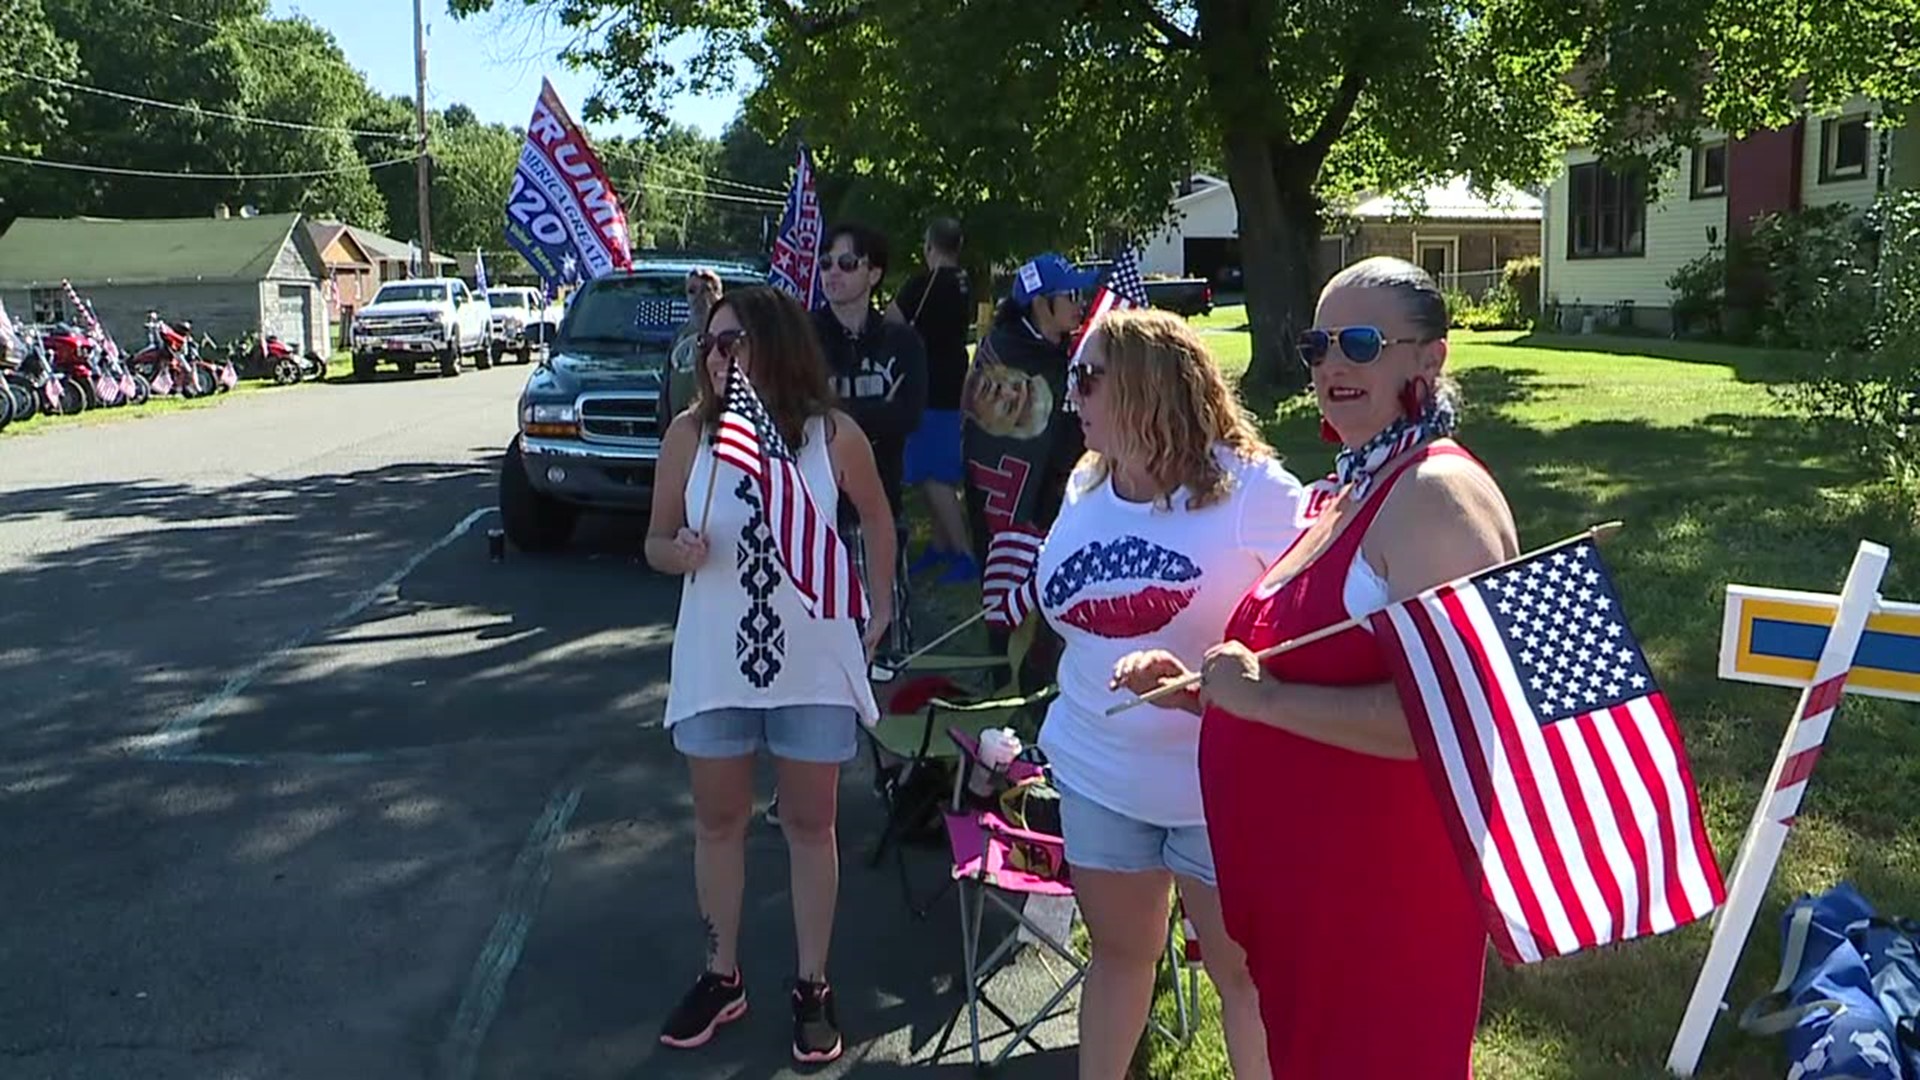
[440,788,580,1080]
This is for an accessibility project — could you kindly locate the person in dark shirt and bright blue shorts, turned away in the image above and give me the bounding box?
[887,217,979,584]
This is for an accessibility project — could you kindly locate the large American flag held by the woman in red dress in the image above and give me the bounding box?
[1369,540,1726,965]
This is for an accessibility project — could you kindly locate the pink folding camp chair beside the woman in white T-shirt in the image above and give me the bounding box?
[929,728,1200,1070]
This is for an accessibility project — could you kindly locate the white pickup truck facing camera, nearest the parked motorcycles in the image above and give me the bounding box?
[349,277,493,379]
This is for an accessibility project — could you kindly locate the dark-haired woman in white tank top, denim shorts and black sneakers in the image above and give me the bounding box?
[647,286,895,1063]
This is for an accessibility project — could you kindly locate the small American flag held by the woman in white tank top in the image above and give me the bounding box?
[714,363,868,619]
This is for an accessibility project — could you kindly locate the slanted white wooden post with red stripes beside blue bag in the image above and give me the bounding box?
[1667,540,1887,1076]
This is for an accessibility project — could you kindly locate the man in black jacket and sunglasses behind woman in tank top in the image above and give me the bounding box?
[814,225,927,657]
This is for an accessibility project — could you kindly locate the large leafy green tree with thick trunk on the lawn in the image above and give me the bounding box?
[449,0,1920,382]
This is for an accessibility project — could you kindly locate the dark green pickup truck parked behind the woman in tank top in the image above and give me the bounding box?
[499,259,766,552]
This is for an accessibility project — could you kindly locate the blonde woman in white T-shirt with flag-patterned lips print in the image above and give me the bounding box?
[1035,309,1302,1080]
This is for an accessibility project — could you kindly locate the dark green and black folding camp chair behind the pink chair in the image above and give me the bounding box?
[868,617,1056,907]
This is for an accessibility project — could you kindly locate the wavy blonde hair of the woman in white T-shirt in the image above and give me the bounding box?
[1081,309,1273,509]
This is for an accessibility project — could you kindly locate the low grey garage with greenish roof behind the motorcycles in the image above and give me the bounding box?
[0,213,326,354]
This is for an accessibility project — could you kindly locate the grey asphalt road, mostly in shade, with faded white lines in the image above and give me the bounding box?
[0,367,1073,1080]
